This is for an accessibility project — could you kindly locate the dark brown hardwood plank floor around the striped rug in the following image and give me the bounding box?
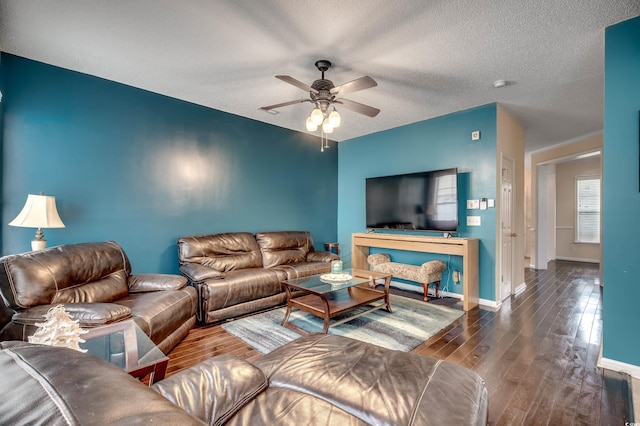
[167,261,633,425]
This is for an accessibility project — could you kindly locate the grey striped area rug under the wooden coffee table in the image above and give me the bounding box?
[222,294,464,354]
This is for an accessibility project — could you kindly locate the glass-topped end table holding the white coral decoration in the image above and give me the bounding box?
[80,319,169,385]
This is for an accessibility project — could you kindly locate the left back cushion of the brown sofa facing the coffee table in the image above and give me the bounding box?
[178,232,262,272]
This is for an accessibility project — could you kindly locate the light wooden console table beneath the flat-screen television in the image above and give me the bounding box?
[351,233,480,311]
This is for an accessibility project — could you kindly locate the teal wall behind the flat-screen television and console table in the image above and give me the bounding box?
[338,104,497,300]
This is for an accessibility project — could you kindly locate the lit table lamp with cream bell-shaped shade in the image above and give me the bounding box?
[9,192,64,251]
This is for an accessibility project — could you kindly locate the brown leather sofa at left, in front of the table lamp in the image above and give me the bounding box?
[0,241,198,353]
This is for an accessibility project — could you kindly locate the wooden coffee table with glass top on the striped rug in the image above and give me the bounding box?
[282,269,392,333]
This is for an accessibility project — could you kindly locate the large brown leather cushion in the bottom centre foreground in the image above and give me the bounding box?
[253,334,487,425]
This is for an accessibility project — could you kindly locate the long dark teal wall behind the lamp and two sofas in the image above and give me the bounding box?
[0,53,338,273]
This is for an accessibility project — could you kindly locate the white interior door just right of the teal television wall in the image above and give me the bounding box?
[500,156,517,300]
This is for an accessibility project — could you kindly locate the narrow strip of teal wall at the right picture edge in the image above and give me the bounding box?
[602,18,640,366]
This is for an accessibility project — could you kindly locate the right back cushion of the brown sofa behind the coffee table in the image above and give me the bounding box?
[256,231,313,268]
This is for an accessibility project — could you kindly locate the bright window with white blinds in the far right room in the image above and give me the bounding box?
[576,176,600,244]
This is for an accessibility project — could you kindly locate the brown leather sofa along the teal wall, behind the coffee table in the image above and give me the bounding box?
[178,231,340,324]
